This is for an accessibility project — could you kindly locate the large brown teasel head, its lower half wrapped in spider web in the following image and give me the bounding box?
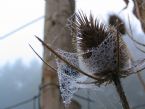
[68,12,130,82]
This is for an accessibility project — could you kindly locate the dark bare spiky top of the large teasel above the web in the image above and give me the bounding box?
[71,12,108,58]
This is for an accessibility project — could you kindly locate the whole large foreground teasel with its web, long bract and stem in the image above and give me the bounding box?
[32,10,145,109]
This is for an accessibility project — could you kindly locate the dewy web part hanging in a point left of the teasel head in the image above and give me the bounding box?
[56,49,105,104]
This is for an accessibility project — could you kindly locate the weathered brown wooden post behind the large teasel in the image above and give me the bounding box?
[41,0,80,109]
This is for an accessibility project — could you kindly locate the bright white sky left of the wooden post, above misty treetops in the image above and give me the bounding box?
[0,0,45,65]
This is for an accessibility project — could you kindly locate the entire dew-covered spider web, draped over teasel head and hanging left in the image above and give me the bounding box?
[56,29,145,104]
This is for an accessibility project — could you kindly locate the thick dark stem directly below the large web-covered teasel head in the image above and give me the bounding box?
[112,74,130,109]
